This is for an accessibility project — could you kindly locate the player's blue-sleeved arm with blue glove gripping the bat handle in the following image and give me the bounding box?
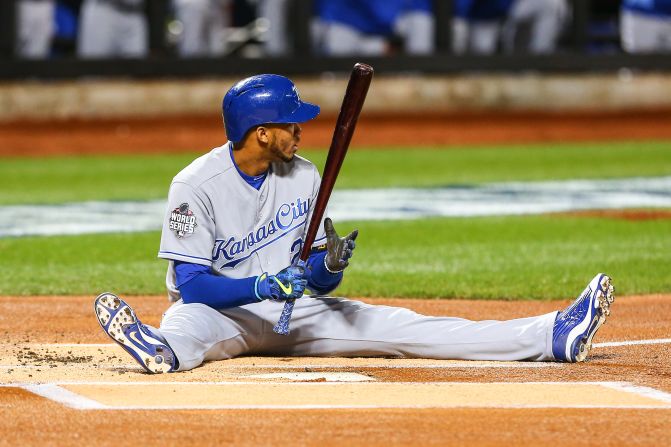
[174,261,307,309]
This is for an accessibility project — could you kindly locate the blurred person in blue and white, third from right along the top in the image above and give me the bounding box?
[452,0,516,54]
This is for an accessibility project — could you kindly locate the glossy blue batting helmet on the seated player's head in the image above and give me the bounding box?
[222,74,319,143]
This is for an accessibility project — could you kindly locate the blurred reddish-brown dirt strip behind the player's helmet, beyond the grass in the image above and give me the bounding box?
[0,111,671,156]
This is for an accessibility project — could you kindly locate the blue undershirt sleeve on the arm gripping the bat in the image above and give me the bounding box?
[173,261,259,309]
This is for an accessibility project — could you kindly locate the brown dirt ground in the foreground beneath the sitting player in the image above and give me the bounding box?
[0,295,671,446]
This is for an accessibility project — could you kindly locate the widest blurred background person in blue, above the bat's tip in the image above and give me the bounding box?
[313,0,434,56]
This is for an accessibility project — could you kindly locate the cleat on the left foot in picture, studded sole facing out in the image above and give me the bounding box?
[93,293,177,374]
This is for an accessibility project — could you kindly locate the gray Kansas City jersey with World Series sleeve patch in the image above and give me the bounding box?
[158,143,326,301]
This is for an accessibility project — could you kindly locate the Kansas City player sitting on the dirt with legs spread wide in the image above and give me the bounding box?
[94,74,613,373]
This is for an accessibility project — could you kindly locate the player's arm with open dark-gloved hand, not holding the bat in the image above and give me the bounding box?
[307,217,359,295]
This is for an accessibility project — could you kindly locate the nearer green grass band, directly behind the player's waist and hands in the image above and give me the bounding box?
[0,216,671,299]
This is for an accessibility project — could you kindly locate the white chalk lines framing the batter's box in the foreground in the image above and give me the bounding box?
[0,382,671,411]
